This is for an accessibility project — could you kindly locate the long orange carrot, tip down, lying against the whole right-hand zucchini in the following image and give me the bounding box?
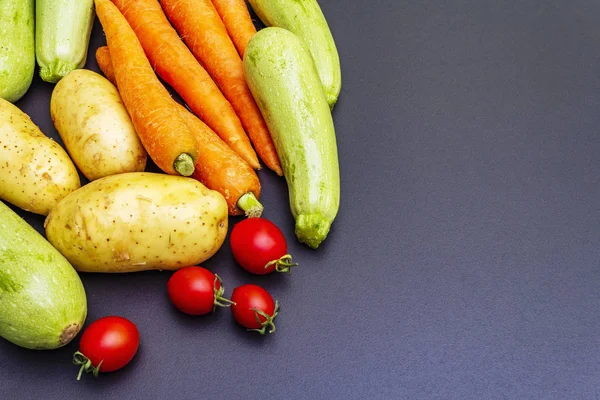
[160,0,283,176]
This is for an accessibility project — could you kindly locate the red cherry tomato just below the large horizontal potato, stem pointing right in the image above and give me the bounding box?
[167,266,237,315]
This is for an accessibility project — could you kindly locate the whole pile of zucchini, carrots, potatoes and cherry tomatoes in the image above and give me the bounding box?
[0,0,341,379]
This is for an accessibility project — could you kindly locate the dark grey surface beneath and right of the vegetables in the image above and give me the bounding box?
[0,0,600,400]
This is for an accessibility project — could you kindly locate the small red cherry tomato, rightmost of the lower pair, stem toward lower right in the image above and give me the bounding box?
[231,284,279,334]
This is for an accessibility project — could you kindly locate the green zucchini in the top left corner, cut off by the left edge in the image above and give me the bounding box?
[0,0,35,103]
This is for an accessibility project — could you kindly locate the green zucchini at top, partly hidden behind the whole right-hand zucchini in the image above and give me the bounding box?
[248,0,342,109]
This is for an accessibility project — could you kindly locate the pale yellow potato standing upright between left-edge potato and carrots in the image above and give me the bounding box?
[50,69,148,181]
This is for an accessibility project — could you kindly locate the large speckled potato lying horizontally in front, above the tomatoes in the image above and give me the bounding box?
[45,172,228,272]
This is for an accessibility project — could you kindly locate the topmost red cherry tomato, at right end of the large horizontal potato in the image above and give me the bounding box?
[229,218,298,275]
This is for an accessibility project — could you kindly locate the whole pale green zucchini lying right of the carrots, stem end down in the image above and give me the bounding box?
[244,27,340,249]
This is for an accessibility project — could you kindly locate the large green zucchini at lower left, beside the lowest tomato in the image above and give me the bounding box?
[0,201,87,350]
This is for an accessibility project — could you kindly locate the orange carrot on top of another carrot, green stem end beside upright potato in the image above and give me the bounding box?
[95,0,198,176]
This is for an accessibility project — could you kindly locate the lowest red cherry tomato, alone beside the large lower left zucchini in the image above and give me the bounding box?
[73,316,140,380]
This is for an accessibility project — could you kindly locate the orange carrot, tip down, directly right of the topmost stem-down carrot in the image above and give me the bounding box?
[112,0,260,169]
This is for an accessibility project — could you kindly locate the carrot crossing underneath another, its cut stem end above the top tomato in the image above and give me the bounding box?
[96,46,263,217]
